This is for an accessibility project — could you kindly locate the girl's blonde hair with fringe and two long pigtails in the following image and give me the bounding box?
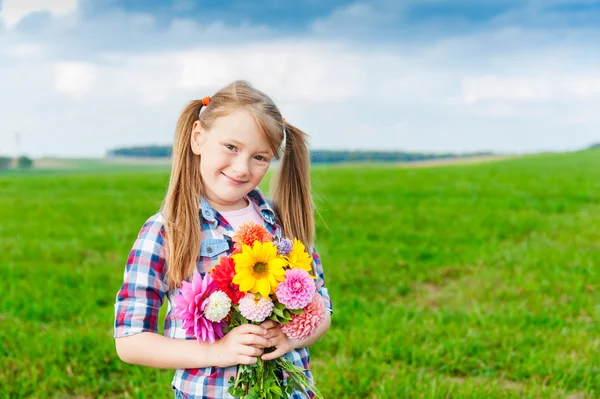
[161,81,315,289]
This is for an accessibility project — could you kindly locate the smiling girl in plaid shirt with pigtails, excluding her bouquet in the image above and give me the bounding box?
[114,81,331,399]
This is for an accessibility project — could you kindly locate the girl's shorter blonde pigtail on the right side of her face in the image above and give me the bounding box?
[273,123,315,248]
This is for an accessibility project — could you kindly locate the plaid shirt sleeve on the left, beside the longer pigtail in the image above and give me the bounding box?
[114,214,168,338]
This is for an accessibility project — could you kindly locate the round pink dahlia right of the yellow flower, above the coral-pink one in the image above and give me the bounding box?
[275,269,317,309]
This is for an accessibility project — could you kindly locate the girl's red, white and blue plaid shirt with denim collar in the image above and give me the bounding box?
[114,188,332,399]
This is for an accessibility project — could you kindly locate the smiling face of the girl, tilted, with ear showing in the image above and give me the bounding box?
[191,108,273,211]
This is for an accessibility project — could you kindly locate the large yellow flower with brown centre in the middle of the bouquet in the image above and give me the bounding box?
[231,241,288,298]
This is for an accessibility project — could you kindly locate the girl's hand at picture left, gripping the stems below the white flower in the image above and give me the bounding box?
[211,324,272,367]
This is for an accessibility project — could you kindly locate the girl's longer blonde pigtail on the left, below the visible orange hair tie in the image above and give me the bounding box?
[161,100,203,289]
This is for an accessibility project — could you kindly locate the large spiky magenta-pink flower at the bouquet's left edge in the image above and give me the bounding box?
[173,272,226,343]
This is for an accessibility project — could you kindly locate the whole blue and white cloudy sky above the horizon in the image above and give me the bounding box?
[0,0,600,157]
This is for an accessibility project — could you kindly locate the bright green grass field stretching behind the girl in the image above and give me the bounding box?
[0,150,600,399]
